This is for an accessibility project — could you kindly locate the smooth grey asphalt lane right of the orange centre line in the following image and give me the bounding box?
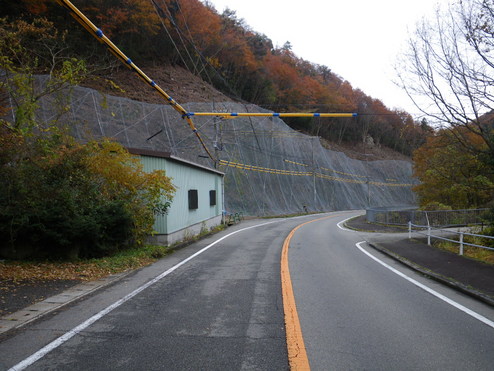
[289,214,494,370]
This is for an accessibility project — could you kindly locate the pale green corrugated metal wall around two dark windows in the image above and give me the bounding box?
[140,156,223,234]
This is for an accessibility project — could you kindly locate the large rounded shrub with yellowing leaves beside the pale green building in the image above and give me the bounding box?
[0,130,174,259]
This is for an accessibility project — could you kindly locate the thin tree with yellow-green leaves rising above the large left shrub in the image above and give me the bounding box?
[0,18,87,135]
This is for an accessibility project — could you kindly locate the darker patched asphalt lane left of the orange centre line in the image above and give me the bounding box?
[0,217,320,370]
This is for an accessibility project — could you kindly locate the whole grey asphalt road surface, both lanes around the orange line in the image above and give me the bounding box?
[0,213,494,370]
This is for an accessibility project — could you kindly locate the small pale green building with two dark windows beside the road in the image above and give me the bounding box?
[127,148,225,245]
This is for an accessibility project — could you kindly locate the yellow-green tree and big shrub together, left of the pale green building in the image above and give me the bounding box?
[0,19,174,260]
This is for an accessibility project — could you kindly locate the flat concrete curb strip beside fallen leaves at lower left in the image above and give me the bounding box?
[0,270,134,335]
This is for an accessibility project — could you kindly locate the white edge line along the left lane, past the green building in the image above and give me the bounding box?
[8,219,286,371]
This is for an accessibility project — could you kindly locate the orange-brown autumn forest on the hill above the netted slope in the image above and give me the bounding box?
[3,0,425,155]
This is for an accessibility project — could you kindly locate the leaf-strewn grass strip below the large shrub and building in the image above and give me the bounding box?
[0,225,226,281]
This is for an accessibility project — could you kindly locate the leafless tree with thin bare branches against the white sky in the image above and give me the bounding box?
[397,0,494,160]
